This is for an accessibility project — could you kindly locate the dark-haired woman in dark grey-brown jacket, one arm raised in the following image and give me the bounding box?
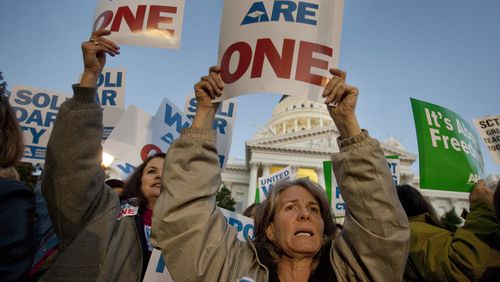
[41,30,164,281]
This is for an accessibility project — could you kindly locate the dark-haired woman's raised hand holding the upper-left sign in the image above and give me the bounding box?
[80,29,120,87]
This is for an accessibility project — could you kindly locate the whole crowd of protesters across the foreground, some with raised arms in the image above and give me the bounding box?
[0,30,500,281]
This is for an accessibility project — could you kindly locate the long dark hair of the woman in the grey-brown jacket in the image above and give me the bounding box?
[120,153,165,213]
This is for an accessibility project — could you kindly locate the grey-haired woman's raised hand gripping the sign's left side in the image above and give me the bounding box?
[192,66,224,128]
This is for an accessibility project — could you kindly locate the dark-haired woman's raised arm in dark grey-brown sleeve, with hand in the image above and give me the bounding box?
[42,30,118,249]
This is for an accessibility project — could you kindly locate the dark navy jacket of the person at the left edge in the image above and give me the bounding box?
[0,178,35,281]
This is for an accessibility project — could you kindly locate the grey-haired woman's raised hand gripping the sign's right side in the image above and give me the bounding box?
[322,69,361,138]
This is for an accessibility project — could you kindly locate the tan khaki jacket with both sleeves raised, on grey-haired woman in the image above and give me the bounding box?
[152,128,410,281]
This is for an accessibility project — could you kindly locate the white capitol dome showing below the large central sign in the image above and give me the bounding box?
[254,96,333,138]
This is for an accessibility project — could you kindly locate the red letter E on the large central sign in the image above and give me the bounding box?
[295,41,333,86]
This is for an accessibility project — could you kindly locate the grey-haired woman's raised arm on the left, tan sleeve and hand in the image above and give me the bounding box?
[152,68,248,281]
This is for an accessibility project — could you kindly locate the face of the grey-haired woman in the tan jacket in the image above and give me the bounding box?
[266,186,324,258]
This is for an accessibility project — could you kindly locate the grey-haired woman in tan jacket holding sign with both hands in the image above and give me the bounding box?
[152,67,410,281]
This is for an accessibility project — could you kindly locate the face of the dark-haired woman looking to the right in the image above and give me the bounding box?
[141,158,163,209]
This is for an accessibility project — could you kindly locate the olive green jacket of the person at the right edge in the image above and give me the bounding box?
[409,204,500,281]
